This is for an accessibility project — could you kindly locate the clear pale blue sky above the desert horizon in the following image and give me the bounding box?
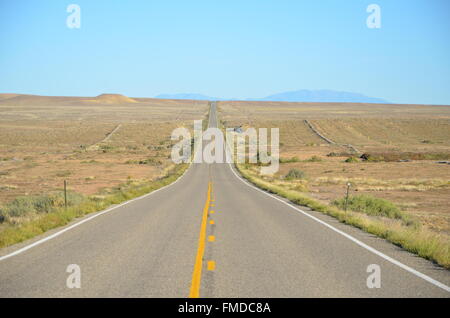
[0,0,450,104]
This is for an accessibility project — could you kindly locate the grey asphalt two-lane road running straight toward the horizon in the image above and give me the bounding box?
[0,103,450,297]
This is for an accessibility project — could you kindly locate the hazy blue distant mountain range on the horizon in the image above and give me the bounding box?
[155,89,389,104]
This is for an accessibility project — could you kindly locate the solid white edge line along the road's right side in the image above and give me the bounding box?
[228,156,450,292]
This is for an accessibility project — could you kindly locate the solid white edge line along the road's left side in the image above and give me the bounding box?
[0,165,191,262]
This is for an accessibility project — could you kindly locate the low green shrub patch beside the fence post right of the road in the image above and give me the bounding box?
[331,194,417,225]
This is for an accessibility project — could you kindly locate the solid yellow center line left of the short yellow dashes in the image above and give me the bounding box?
[189,182,214,298]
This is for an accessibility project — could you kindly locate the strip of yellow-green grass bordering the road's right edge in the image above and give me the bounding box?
[236,164,450,269]
